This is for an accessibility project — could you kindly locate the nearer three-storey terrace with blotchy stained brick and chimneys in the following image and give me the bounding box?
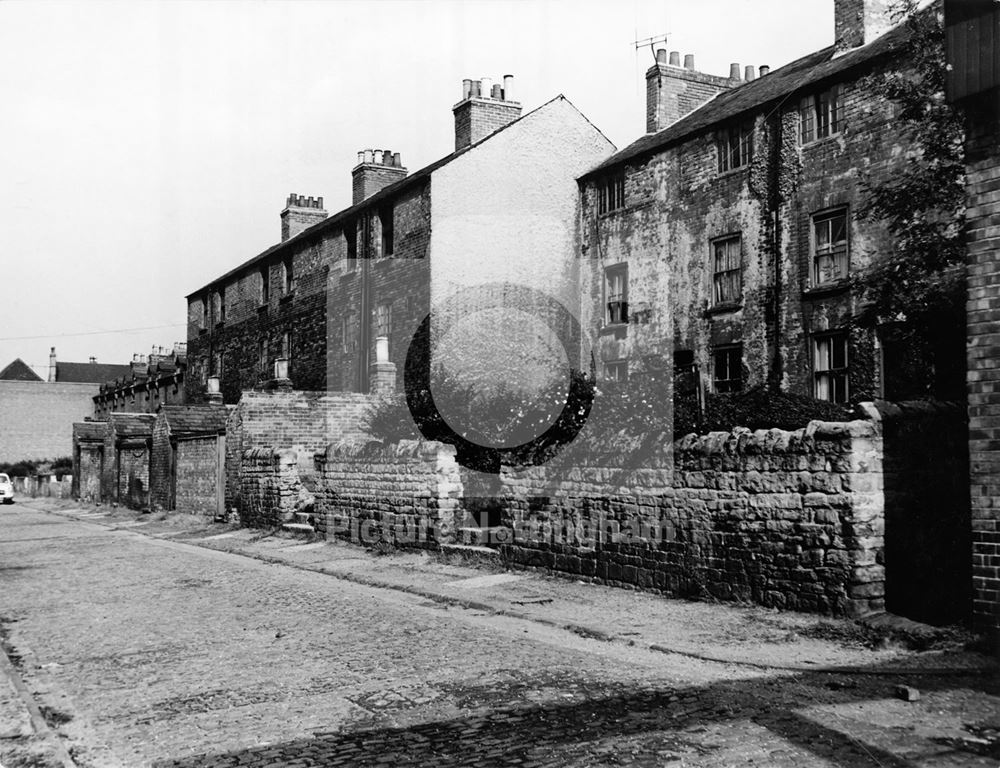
[580,0,952,402]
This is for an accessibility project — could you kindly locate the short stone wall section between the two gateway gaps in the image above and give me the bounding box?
[316,440,462,547]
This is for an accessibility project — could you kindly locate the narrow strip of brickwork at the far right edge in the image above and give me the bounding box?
[966,112,1000,637]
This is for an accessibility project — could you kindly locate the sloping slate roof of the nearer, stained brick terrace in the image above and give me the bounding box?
[579,18,926,181]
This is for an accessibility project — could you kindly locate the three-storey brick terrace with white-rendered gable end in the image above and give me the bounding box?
[187,76,614,403]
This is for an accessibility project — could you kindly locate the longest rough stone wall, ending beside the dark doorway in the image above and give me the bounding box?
[500,421,885,616]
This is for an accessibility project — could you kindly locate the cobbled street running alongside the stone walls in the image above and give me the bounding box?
[0,500,1000,768]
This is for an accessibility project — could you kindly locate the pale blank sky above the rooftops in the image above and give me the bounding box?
[0,0,833,376]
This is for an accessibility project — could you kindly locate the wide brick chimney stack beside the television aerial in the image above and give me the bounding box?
[646,48,743,133]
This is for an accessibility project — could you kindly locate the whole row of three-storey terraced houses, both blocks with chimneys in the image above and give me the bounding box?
[74,0,1000,636]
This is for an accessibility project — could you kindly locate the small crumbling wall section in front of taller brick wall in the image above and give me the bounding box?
[240,448,308,528]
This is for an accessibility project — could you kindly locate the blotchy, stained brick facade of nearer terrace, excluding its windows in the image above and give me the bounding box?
[582,55,920,399]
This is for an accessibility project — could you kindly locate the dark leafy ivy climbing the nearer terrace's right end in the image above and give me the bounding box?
[853,0,965,397]
